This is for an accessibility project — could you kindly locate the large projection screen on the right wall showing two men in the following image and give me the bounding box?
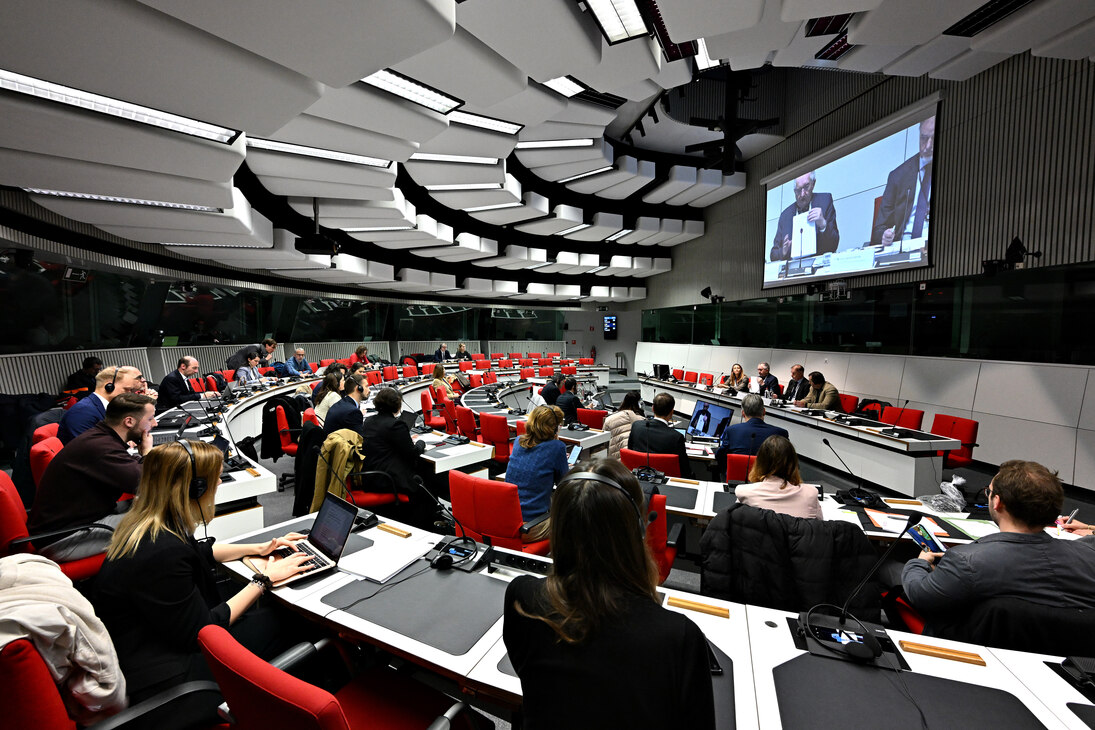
[758,104,945,289]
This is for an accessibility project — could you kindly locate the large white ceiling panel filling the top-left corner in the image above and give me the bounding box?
[0,0,320,136]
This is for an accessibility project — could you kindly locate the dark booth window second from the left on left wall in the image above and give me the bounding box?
[160,281,273,345]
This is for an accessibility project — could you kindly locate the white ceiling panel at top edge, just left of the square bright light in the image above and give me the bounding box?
[457,0,601,83]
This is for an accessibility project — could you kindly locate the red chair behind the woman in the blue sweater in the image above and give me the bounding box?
[449,470,551,555]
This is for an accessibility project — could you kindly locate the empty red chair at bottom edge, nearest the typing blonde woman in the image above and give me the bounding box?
[198,624,471,730]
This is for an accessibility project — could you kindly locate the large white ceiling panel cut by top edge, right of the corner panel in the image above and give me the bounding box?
[140,0,457,86]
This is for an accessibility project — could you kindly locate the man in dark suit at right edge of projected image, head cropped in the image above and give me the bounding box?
[871,115,935,246]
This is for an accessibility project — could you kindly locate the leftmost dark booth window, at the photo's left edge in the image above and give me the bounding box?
[0,248,148,354]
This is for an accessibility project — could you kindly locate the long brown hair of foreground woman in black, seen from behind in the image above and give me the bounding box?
[517,459,658,644]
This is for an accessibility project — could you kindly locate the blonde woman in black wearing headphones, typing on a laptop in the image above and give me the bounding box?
[94,441,315,712]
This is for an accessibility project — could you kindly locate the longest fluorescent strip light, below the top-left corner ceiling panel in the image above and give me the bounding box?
[0,69,239,144]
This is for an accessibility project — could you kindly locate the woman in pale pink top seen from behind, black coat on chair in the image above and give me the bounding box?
[734,436,821,519]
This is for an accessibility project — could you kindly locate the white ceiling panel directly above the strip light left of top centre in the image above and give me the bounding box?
[393,27,527,106]
